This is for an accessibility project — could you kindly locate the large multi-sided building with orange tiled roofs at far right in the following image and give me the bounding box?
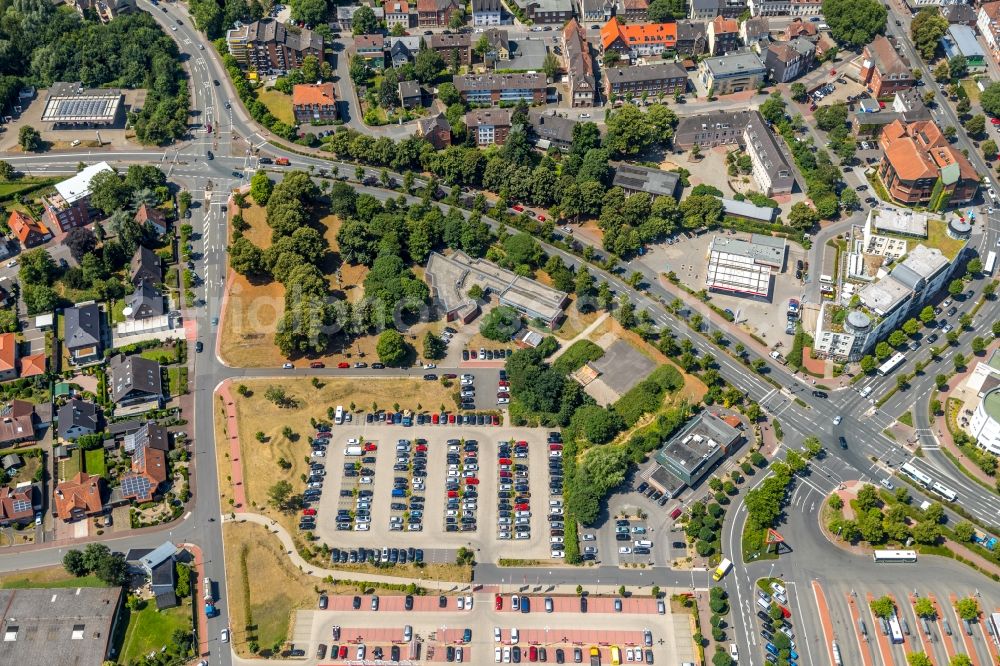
[879,120,980,208]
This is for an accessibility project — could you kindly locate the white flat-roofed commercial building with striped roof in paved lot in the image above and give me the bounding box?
[705,234,785,298]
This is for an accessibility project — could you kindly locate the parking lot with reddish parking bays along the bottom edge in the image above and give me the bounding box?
[294,590,689,664]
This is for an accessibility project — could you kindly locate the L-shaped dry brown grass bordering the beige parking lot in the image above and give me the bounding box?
[226,377,455,520]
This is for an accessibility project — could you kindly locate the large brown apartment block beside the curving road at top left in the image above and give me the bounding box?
[226,18,323,73]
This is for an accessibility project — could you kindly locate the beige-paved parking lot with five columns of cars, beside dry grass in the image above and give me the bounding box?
[312,419,551,559]
